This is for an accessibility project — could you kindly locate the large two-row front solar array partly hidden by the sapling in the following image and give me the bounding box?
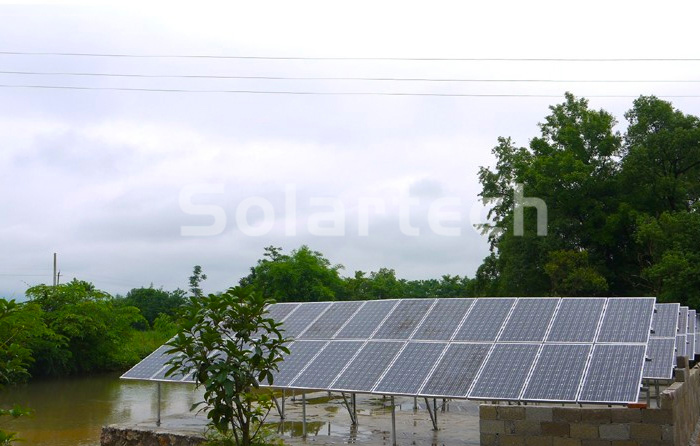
[122,297,656,404]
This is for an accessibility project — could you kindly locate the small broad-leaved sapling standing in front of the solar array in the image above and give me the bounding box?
[168,288,289,446]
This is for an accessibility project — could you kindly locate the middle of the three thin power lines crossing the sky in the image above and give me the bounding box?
[0,70,700,83]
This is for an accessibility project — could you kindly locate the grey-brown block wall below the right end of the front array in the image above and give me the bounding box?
[480,362,700,446]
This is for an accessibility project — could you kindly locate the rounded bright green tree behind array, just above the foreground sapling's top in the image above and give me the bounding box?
[240,245,344,302]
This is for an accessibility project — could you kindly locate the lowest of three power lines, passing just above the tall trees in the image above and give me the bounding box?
[0,84,700,99]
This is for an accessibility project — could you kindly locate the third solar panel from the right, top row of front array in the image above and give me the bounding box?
[498,297,559,342]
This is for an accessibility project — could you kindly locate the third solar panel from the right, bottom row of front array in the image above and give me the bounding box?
[469,344,540,400]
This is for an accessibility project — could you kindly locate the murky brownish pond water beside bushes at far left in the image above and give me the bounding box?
[0,374,200,446]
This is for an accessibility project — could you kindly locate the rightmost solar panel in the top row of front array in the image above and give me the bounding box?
[597,297,655,344]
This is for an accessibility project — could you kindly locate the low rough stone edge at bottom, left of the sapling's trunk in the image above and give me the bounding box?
[100,426,204,446]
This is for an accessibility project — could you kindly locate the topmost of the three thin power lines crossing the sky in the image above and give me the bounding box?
[0,51,700,62]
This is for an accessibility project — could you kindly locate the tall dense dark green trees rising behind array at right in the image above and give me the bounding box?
[480,94,700,307]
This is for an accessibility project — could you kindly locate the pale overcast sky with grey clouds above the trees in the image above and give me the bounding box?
[0,1,700,298]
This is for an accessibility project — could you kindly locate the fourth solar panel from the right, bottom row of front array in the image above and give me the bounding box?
[420,344,493,398]
